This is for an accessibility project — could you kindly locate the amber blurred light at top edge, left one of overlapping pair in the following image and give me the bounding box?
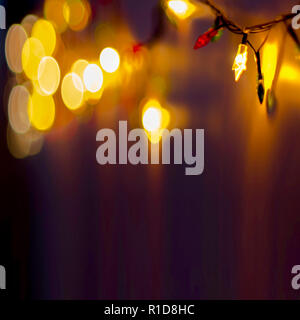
[44,0,68,33]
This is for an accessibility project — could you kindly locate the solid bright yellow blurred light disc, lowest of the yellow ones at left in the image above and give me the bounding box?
[28,91,55,131]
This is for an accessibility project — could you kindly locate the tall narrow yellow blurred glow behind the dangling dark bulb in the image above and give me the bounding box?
[262,43,278,91]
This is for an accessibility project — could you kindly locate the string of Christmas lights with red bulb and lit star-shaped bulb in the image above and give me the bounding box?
[145,0,300,104]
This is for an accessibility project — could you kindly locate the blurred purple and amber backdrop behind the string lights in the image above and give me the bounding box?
[0,0,300,299]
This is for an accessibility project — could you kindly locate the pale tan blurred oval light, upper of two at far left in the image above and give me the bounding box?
[5,24,27,73]
